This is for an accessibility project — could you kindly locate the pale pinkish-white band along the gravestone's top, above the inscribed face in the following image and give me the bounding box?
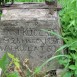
[1,9,58,21]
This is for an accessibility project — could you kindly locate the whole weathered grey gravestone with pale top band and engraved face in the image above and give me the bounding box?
[0,3,62,71]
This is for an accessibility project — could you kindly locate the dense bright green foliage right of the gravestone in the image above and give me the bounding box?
[59,0,77,77]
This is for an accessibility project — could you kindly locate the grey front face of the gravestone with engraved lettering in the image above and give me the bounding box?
[0,20,61,71]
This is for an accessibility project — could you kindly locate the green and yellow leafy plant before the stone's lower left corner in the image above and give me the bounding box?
[0,53,20,77]
